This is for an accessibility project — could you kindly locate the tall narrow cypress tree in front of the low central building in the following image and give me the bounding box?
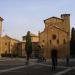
[25,31,32,64]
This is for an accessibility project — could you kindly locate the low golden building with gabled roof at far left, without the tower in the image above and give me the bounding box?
[0,35,19,56]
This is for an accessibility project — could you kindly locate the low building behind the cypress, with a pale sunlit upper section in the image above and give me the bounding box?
[18,33,39,57]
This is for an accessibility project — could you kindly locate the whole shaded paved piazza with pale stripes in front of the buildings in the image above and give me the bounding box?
[0,58,75,75]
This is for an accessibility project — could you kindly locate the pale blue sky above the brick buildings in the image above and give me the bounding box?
[0,0,75,40]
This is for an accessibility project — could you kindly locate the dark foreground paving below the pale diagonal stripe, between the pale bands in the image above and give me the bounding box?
[0,64,64,75]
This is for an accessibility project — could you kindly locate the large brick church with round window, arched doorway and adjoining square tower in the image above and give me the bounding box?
[39,14,70,58]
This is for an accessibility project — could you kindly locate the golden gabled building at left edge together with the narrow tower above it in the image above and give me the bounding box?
[0,17,20,57]
